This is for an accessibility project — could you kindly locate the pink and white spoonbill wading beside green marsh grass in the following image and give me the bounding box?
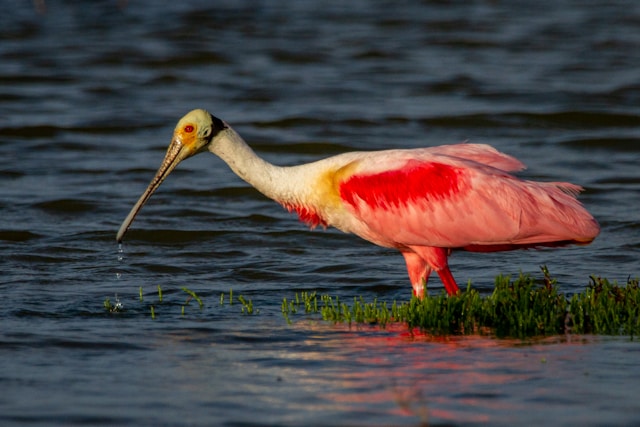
[117,110,600,298]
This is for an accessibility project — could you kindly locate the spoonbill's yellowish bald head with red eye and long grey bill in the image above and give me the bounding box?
[116,109,229,242]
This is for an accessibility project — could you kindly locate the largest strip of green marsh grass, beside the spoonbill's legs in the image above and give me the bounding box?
[282,267,640,338]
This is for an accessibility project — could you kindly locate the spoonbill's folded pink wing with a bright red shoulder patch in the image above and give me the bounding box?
[339,144,599,250]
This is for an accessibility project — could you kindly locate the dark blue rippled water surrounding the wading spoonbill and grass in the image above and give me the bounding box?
[0,0,640,426]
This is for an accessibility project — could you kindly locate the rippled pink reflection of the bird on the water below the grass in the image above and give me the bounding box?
[299,323,589,423]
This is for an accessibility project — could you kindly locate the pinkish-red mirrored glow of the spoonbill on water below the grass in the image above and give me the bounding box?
[302,326,576,423]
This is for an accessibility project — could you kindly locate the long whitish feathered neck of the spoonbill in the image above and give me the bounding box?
[209,127,292,202]
